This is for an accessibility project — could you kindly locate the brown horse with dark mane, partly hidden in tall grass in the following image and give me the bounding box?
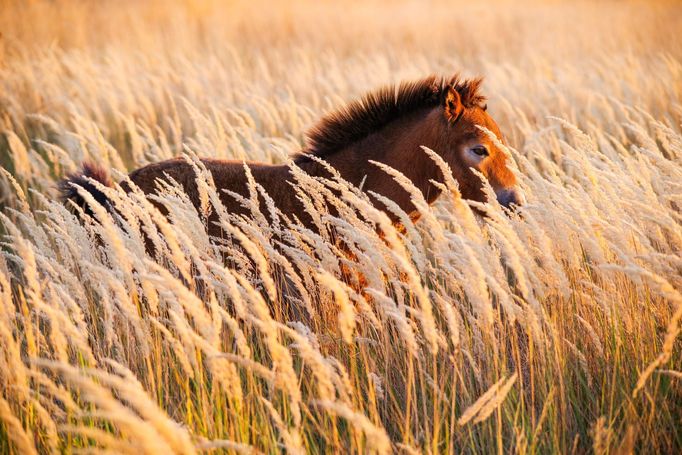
[60,75,521,235]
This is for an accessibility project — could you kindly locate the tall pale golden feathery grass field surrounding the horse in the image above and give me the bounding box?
[0,0,682,454]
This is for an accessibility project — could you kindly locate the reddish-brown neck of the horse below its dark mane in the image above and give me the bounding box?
[302,110,443,205]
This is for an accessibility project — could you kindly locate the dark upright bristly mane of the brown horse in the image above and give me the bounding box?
[293,74,485,163]
